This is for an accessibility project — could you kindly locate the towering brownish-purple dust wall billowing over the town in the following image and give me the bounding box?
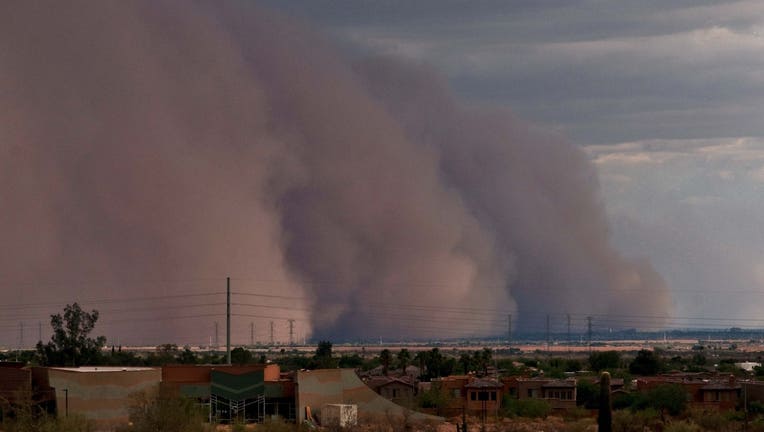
[0,1,670,345]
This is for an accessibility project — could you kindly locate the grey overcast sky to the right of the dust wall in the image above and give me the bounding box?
[266,0,764,327]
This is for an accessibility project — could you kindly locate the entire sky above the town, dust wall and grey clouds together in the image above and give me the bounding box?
[0,1,764,347]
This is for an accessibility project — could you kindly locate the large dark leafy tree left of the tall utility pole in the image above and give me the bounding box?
[37,303,106,366]
